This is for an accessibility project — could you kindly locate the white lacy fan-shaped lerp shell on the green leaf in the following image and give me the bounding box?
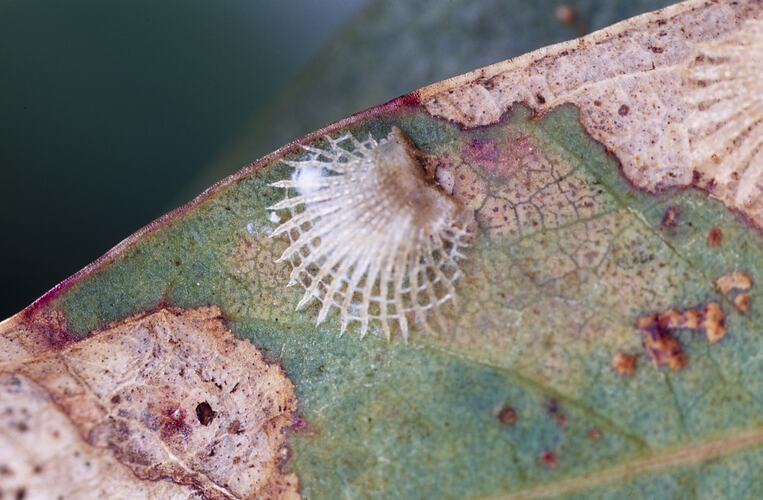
[270,127,474,339]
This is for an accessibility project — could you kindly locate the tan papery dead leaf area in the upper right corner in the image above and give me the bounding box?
[420,1,763,227]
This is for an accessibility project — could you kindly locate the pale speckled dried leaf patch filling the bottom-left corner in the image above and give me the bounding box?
[0,373,202,500]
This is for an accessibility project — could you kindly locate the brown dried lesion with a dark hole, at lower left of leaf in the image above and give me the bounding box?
[0,307,299,498]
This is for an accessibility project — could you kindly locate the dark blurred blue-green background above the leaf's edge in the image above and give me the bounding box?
[0,0,669,319]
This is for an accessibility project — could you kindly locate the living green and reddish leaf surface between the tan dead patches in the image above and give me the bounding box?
[2,0,763,498]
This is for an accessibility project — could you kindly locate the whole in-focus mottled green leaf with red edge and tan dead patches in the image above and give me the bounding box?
[0,1,763,498]
